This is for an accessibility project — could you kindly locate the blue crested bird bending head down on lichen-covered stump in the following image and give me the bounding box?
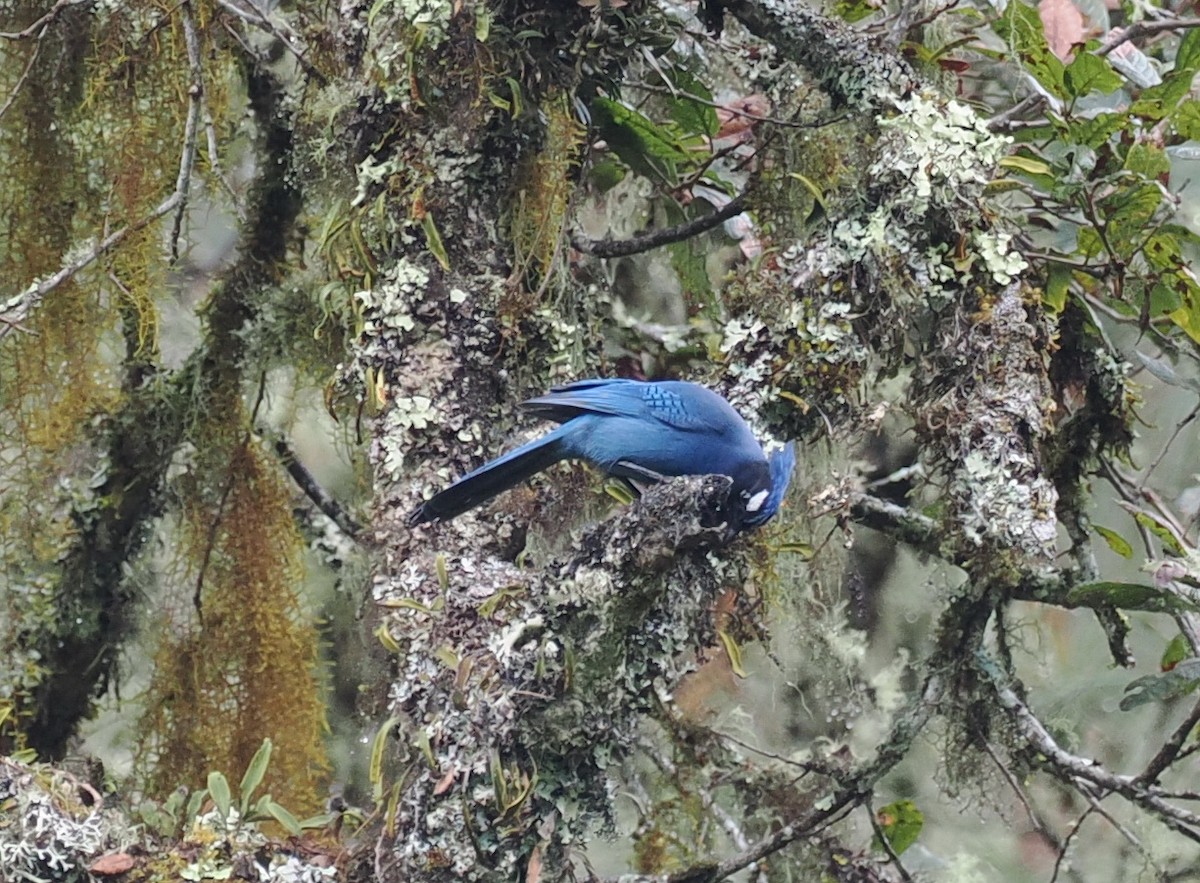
[408,379,796,528]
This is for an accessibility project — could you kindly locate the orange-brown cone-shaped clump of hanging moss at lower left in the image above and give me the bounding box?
[139,402,328,812]
